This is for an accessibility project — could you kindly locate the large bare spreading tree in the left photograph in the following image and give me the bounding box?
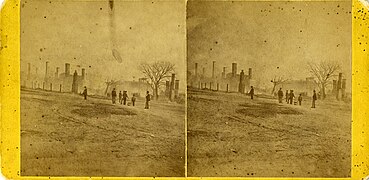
[139,61,174,99]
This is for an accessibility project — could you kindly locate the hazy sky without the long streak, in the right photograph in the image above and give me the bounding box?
[187,1,351,90]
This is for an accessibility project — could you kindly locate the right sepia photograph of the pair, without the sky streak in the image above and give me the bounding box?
[186,1,350,178]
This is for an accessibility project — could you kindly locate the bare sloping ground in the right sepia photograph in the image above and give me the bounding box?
[188,89,351,177]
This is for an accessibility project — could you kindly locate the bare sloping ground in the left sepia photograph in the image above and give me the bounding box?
[21,89,185,177]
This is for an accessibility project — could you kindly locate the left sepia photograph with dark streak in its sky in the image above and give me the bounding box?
[20,0,187,177]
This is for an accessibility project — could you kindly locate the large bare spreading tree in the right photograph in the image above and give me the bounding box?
[308,61,341,99]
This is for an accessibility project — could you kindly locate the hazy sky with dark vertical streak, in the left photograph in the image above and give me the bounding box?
[21,0,186,89]
